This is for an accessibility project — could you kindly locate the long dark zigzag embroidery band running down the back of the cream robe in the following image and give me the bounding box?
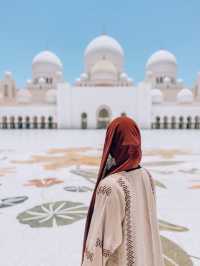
[118,177,136,266]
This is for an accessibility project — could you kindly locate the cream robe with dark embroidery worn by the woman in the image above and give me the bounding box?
[83,167,164,266]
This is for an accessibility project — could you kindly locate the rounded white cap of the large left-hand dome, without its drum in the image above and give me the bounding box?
[32,51,62,68]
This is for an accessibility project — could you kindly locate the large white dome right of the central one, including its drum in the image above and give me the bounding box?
[146,50,177,79]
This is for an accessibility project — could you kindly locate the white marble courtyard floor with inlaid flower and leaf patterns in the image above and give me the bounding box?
[0,130,200,266]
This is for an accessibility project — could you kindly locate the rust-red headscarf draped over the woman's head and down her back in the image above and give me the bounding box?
[82,116,142,261]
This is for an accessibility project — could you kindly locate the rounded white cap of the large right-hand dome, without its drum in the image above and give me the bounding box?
[146,50,177,68]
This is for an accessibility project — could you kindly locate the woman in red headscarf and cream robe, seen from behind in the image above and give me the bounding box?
[82,117,164,266]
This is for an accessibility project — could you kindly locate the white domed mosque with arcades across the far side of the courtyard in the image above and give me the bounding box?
[0,34,200,129]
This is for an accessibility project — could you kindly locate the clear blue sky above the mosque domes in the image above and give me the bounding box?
[0,0,200,86]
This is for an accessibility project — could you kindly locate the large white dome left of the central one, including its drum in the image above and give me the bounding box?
[32,51,63,83]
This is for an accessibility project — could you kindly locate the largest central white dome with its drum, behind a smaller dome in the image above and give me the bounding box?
[84,34,124,72]
